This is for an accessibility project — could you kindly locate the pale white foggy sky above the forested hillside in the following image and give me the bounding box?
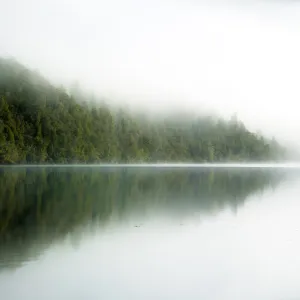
[0,0,300,145]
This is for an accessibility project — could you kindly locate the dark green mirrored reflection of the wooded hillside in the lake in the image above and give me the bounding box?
[0,168,279,270]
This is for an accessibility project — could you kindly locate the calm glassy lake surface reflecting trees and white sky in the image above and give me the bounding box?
[0,165,300,300]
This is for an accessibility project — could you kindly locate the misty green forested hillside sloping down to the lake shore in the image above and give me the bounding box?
[0,59,284,164]
